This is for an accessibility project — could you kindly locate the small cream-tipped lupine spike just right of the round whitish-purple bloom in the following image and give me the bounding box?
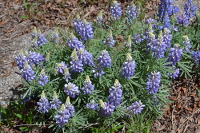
[81,75,94,94]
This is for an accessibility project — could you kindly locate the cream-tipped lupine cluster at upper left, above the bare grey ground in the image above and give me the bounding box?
[31,28,47,47]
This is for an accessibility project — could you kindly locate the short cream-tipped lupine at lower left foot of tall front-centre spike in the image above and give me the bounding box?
[100,100,115,117]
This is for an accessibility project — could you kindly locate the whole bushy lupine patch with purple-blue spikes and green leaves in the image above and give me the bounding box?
[0,0,200,133]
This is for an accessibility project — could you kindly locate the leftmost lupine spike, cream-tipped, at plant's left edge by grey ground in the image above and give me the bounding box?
[15,50,28,70]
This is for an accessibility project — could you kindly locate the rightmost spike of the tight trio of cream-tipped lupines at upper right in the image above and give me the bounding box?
[163,28,172,50]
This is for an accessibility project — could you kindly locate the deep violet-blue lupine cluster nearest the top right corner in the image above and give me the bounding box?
[177,0,197,27]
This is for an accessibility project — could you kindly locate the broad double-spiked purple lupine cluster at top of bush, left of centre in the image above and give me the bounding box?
[73,18,93,41]
